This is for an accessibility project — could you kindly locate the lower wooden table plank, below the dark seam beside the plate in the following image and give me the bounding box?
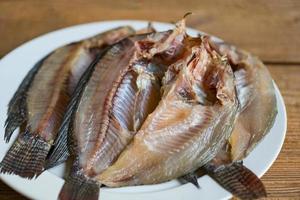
[0,65,300,200]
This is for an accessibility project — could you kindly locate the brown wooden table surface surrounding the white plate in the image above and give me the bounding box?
[0,0,300,200]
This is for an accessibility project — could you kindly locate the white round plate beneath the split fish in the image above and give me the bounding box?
[0,21,287,200]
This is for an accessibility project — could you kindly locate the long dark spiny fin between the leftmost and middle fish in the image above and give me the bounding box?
[46,48,107,169]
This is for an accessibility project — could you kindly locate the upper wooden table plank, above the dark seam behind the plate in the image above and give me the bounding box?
[0,0,300,63]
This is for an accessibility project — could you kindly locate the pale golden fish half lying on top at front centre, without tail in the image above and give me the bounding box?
[97,38,238,187]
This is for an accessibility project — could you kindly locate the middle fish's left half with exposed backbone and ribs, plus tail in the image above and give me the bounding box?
[59,19,189,199]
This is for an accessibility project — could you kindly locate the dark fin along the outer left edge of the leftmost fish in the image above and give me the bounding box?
[4,56,48,142]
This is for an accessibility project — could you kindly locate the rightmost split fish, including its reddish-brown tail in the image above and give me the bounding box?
[184,40,277,199]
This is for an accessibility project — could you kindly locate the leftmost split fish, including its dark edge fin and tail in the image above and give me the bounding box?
[0,27,134,178]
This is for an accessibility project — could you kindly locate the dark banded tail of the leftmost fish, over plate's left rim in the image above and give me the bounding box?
[0,131,51,179]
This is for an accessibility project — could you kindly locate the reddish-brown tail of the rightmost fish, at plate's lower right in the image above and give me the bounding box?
[205,162,267,199]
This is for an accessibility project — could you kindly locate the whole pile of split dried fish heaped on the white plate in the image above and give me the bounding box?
[0,17,277,200]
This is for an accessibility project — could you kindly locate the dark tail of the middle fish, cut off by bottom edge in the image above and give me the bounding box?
[58,173,100,200]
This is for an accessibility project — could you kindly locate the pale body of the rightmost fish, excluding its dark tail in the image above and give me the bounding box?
[212,43,277,161]
